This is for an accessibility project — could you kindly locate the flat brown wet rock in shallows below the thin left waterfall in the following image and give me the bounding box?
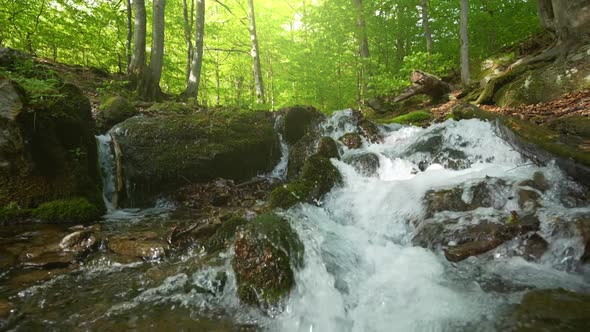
[108,232,169,261]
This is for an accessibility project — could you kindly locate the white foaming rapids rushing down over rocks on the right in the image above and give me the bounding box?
[268,111,589,332]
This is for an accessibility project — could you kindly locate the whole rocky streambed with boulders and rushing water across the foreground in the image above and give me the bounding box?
[0,107,590,331]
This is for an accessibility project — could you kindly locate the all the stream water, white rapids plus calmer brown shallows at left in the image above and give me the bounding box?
[0,111,590,332]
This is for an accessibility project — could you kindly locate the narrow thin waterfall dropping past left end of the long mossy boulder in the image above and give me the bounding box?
[96,133,119,213]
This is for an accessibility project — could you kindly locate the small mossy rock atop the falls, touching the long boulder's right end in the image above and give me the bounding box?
[279,106,325,145]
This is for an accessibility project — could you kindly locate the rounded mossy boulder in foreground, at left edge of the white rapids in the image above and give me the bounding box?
[232,214,304,309]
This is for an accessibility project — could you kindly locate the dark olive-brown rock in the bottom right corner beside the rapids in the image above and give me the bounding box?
[512,289,590,331]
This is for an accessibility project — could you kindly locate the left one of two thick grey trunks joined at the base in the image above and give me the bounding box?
[127,0,146,88]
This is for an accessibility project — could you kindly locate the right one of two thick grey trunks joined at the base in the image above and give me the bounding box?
[139,0,166,100]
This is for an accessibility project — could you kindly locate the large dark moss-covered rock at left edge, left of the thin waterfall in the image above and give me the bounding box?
[0,64,102,209]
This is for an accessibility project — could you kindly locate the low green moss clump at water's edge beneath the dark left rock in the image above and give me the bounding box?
[32,198,102,223]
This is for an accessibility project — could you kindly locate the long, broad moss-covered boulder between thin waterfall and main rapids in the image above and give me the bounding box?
[111,111,280,206]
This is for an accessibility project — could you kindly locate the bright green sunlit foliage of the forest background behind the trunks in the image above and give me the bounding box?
[0,0,541,110]
